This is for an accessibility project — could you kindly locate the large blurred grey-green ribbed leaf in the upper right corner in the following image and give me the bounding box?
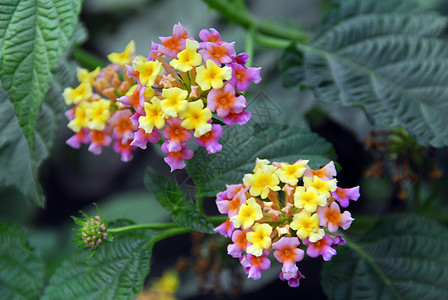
[282,0,448,147]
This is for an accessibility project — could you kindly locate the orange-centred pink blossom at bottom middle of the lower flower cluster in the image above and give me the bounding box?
[272,237,304,280]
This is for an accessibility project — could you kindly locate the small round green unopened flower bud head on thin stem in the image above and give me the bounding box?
[72,212,108,250]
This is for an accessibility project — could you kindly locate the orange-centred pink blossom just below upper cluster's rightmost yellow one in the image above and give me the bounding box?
[207,83,247,117]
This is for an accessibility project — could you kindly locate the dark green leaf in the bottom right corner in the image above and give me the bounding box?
[322,215,448,300]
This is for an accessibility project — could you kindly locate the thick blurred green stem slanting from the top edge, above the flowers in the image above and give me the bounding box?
[204,0,308,42]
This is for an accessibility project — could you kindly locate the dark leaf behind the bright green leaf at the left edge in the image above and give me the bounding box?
[0,25,85,207]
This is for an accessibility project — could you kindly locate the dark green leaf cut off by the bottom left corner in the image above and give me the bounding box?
[0,222,45,300]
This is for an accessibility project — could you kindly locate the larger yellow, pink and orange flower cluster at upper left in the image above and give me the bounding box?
[63,23,261,171]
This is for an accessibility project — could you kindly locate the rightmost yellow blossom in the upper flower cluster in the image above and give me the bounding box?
[196,59,232,91]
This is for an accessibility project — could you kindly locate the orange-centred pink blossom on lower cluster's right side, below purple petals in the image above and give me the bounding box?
[317,201,354,233]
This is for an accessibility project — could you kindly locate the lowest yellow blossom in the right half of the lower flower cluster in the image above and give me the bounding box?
[290,210,325,243]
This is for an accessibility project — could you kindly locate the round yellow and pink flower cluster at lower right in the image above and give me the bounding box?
[215,158,360,287]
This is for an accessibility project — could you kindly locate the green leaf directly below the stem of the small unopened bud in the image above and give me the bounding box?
[41,223,153,300]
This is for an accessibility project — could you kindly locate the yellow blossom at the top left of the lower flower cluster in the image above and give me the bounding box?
[243,165,280,199]
